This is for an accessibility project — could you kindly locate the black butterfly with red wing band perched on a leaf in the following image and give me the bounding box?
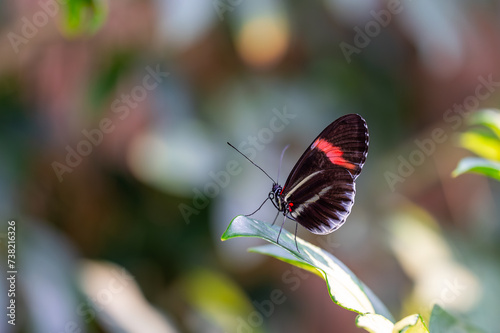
[228,114,369,250]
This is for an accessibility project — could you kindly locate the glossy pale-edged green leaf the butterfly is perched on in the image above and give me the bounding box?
[221,216,393,320]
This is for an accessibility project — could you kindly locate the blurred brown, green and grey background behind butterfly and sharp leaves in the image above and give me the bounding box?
[0,0,500,333]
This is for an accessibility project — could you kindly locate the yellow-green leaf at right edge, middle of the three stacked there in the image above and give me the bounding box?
[460,131,500,161]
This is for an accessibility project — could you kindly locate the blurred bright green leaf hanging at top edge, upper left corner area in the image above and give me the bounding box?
[63,0,107,36]
